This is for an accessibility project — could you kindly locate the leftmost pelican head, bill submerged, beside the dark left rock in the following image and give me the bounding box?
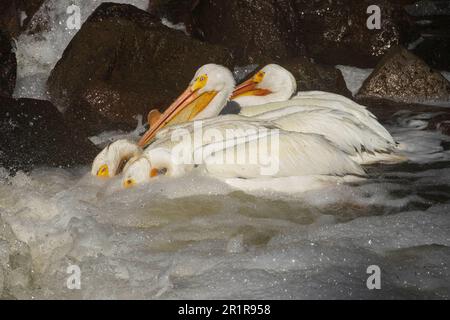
[91,140,142,178]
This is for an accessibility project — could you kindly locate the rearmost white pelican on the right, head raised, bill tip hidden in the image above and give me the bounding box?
[232,64,405,164]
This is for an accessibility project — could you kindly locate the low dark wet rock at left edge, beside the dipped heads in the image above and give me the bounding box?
[0,97,99,171]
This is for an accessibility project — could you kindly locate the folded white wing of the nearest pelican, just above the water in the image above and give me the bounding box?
[204,131,364,178]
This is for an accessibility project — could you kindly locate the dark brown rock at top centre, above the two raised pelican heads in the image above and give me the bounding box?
[193,0,304,64]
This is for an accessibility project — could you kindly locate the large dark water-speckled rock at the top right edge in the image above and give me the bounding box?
[292,0,414,67]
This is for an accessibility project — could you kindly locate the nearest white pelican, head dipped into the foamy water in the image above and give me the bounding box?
[122,126,365,188]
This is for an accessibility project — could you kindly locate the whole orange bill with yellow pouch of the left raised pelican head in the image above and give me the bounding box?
[138,87,217,147]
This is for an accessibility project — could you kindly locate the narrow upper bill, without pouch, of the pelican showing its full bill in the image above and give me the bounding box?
[138,87,198,147]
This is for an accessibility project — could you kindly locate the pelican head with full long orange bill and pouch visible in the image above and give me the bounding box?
[139,64,236,147]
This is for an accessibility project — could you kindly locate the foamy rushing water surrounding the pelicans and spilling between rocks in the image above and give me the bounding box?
[0,0,450,299]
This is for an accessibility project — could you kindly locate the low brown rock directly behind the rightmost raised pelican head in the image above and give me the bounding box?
[282,57,352,97]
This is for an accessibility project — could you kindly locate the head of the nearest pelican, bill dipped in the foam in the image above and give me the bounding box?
[122,148,193,189]
